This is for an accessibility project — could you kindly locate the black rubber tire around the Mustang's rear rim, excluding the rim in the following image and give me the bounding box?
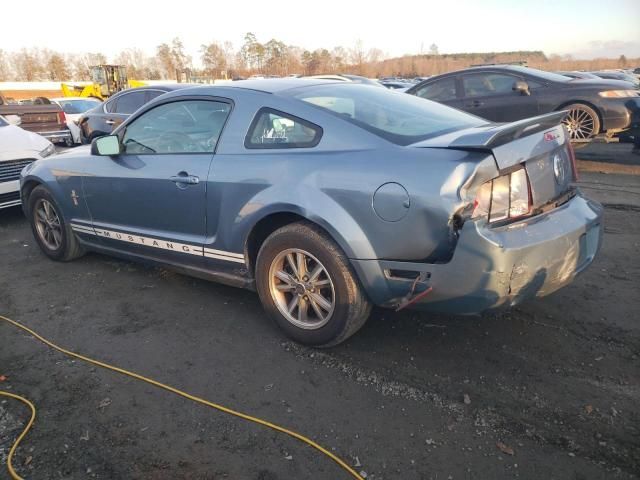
[256,225,354,346]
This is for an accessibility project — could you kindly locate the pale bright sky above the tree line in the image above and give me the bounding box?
[0,0,640,60]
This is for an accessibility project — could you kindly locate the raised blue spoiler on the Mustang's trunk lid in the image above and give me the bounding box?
[448,111,567,150]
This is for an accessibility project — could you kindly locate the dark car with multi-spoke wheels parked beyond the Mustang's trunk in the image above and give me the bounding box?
[407,65,640,142]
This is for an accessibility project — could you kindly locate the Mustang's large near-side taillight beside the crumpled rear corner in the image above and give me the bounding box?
[472,168,531,222]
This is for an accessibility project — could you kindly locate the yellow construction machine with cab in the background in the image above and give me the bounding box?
[60,65,145,100]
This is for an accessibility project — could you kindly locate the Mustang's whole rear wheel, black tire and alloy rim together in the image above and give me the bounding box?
[256,222,371,347]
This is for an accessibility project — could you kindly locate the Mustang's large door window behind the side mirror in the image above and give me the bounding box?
[122,100,231,155]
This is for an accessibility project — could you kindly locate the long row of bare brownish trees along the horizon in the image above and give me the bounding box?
[0,32,640,81]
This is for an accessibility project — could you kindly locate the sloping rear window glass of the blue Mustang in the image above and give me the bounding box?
[291,84,487,145]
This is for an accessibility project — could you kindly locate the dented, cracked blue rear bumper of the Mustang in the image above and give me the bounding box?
[352,194,603,314]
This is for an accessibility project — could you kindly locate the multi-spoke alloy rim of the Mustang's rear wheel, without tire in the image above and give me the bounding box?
[269,248,335,330]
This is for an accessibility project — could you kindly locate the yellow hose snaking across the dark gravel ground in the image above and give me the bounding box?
[0,315,363,480]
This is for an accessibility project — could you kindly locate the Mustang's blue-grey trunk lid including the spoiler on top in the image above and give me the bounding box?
[411,112,574,208]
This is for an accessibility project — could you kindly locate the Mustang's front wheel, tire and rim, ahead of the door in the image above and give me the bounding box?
[27,185,84,262]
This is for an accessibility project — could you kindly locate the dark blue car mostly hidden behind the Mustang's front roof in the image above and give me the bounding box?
[78,83,194,143]
